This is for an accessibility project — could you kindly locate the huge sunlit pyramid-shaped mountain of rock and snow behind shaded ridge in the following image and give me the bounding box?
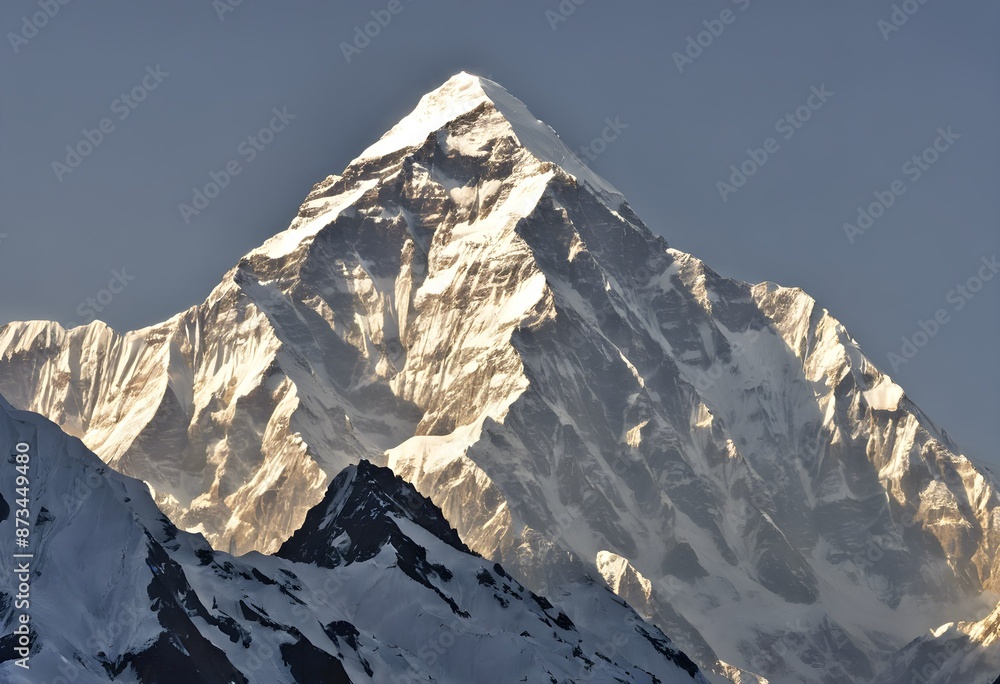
[0,74,1000,684]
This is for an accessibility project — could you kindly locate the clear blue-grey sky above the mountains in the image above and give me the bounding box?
[0,0,1000,464]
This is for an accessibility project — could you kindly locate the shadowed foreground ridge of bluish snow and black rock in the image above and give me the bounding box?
[0,398,707,684]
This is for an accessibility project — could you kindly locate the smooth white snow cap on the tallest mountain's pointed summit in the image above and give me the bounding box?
[355,71,624,204]
